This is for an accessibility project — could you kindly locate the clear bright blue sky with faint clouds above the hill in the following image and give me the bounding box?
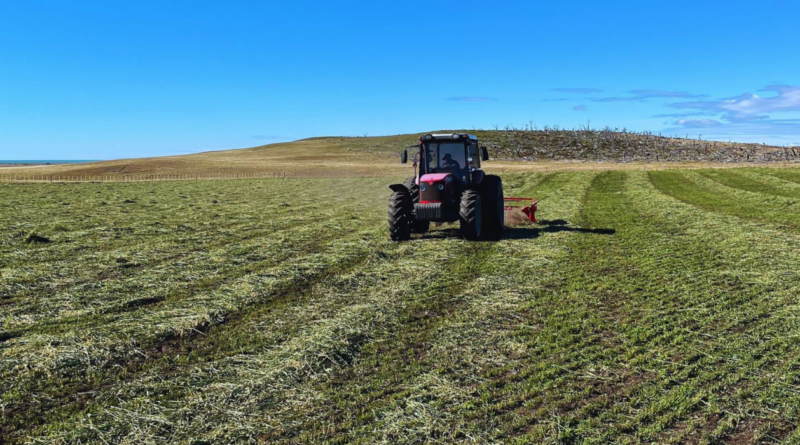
[0,0,800,159]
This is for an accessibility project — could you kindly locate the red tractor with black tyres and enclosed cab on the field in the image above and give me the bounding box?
[389,133,505,241]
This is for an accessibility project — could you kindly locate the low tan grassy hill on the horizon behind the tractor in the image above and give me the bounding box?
[0,129,800,178]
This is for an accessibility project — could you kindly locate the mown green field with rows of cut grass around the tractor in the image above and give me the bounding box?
[0,169,800,444]
